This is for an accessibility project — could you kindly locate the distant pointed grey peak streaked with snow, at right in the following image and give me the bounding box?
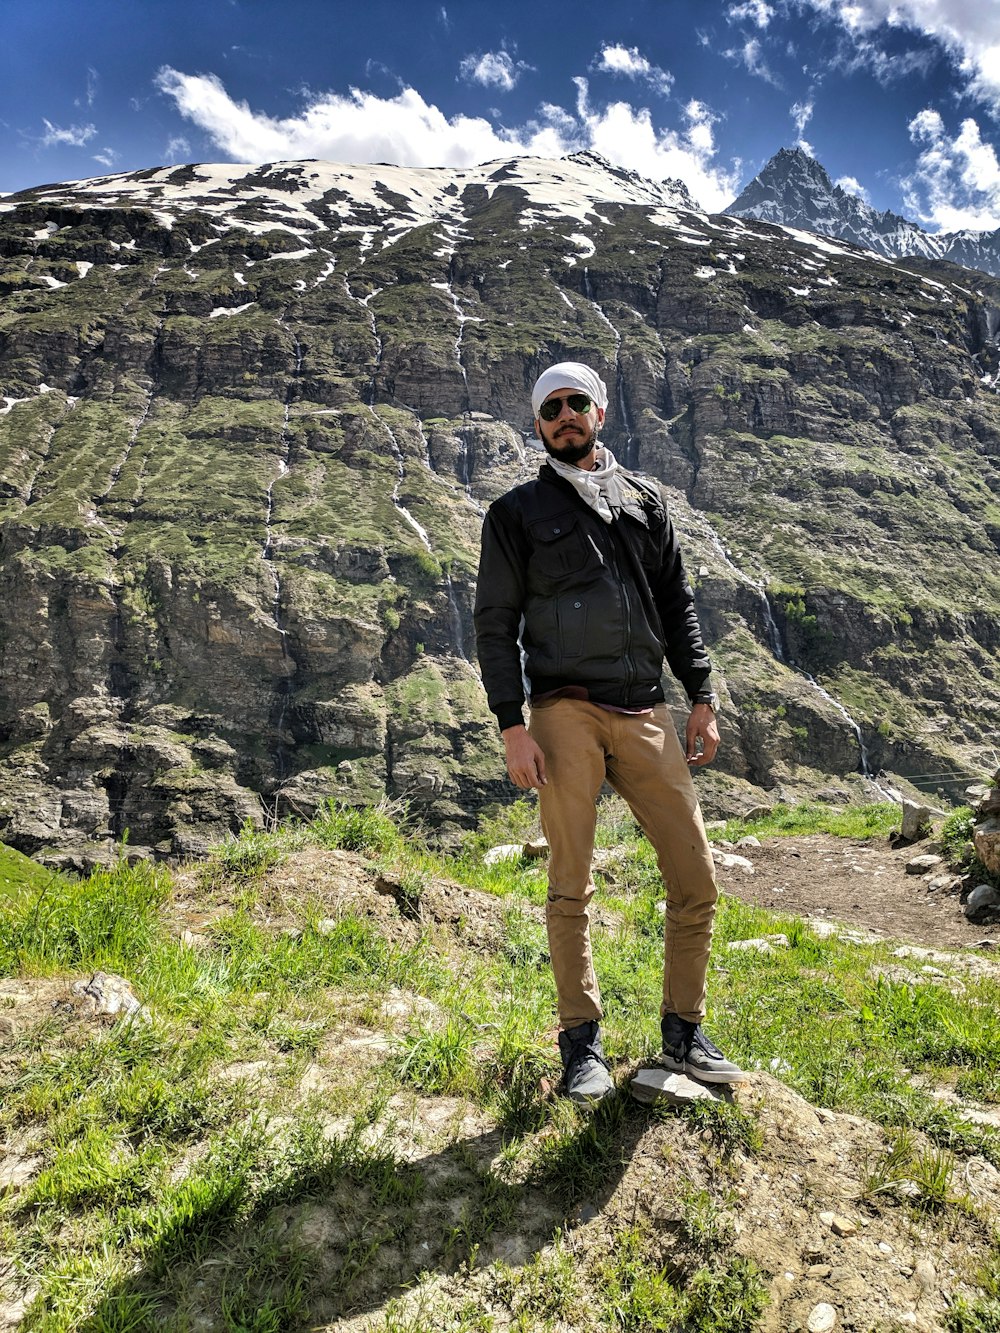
[725,148,1000,276]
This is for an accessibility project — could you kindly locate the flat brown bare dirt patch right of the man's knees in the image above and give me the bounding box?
[719,833,1000,949]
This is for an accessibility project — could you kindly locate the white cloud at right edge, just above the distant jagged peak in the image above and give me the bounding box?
[903,108,1000,232]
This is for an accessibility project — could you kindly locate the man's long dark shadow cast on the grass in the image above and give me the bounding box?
[70,1085,736,1333]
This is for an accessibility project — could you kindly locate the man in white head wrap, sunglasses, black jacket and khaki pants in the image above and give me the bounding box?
[476,361,744,1102]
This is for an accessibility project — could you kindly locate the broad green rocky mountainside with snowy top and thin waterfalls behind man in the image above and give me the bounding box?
[0,155,1000,861]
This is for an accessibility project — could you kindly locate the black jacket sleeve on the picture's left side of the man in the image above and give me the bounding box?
[475,500,528,730]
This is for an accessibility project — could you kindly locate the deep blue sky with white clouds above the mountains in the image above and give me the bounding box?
[0,0,1000,231]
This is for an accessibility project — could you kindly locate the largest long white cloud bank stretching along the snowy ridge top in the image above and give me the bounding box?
[156,67,739,212]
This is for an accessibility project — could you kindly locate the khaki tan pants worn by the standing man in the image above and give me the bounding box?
[528,698,717,1028]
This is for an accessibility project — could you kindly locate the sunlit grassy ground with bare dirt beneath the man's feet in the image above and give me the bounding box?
[0,802,1000,1333]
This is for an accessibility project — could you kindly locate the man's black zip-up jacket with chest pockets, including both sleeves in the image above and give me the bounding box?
[476,465,712,728]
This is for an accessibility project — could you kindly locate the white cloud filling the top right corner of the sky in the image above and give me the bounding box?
[799,0,1000,116]
